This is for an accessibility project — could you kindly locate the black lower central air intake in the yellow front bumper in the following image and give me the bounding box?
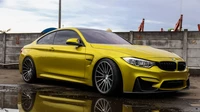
[161,80,184,88]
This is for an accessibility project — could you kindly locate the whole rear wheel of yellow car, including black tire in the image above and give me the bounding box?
[22,57,36,83]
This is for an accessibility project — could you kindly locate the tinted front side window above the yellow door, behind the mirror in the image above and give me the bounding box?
[54,30,80,45]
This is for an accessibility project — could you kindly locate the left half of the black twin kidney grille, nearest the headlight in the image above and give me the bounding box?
[156,61,176,71]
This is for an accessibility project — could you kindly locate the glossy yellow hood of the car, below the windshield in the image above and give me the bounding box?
[91,44,179,58]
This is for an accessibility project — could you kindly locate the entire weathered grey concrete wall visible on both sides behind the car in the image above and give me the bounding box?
[0,30,200,69]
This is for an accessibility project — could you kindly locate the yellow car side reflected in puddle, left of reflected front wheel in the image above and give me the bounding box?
[18,92,92,112]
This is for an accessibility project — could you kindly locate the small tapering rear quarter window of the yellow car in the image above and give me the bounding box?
[37,32,56,44]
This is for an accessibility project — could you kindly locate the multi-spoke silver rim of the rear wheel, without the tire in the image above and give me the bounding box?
[22,59,34,82]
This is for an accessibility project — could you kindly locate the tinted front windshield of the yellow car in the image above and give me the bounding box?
[80,29,130,44]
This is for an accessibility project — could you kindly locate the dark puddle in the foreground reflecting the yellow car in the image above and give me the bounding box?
[0,85,200,112]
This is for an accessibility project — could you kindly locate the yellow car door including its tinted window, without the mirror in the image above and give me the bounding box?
[51,30,85,78]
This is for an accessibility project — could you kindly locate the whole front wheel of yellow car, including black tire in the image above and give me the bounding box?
[93,59,122,95]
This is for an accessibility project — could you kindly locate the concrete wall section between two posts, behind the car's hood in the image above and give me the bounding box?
[133,32,183,57]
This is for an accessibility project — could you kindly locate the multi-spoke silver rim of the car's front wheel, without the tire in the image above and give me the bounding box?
[94,61,113,93]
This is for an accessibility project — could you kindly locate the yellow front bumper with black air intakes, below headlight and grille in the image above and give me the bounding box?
[115,57,189,93]
